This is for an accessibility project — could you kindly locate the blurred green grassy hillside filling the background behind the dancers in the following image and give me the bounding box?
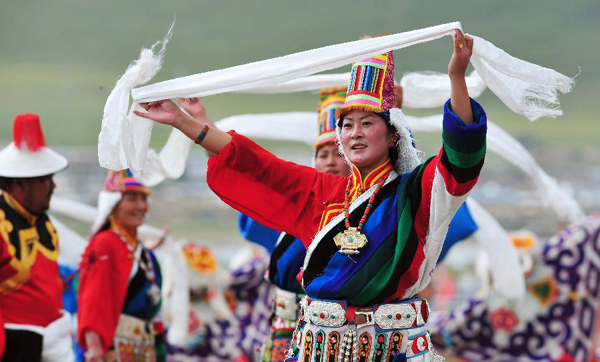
[0,0,600,146]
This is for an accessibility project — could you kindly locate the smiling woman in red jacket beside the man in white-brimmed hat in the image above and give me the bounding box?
[77,170,166,362]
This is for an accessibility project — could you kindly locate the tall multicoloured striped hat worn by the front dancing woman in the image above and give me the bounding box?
[336,52,398,118]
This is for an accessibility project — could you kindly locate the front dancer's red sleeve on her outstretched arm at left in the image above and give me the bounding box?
[207,131,346,246]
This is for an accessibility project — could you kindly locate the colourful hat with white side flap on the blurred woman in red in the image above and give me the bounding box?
[92,169,152,235]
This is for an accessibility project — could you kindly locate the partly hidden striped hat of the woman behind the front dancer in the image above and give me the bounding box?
[315,87,346,149]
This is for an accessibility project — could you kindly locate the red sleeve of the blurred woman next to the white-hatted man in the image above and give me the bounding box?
[77,231,133,353]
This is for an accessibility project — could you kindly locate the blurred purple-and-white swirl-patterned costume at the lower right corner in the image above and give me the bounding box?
[428,215,600,362]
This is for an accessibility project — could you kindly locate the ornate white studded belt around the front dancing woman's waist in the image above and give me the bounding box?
[301,298,429,329]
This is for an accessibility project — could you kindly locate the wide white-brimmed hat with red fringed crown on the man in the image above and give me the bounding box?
[0,113,69,178]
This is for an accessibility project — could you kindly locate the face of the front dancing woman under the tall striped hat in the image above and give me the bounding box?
[341,111,394,175]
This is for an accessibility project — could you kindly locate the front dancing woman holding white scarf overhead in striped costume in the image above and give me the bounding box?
[136,31,486,362]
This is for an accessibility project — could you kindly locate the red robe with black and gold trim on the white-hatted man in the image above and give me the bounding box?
[0,193,63,356]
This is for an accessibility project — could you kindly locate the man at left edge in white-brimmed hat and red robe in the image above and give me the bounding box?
[0,114,73,362]
